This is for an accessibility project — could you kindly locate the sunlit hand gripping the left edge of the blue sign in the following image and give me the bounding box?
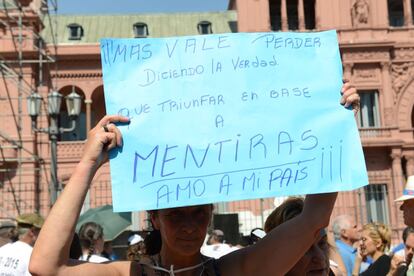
[81,115,129,169]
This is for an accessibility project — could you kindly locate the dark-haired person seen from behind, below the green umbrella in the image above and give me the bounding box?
[79,222,109,263]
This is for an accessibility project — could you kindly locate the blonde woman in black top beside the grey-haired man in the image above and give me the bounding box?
[352,223,391,276]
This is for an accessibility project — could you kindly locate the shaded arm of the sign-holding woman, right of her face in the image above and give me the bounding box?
[219,193,337,276]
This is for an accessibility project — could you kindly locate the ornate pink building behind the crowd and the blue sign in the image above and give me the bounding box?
[0,0,414,242]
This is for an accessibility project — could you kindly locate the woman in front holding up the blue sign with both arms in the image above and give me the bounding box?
[29,84,359,276]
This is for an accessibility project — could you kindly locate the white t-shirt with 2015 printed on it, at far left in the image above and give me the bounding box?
[0,241,33,276]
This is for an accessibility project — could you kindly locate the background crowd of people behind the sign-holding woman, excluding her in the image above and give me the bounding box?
[4,184,414,276]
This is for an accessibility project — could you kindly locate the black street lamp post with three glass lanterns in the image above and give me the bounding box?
[27,87,82,205]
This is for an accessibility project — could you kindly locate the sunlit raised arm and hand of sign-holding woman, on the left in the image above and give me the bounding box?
[29,116,133,275]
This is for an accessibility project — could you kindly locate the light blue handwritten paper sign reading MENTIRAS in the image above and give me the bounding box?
[101,31,368,211]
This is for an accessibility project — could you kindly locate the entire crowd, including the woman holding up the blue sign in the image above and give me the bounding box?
[0,83,414,276]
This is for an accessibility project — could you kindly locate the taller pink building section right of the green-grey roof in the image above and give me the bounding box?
[229,0,414,237]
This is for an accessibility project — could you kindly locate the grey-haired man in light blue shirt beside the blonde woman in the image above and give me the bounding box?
[332,215,360,276]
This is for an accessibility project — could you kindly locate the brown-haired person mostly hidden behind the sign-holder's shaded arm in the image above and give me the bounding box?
[264,197,343,276]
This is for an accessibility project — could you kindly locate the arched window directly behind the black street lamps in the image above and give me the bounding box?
[58,86,86,141]
